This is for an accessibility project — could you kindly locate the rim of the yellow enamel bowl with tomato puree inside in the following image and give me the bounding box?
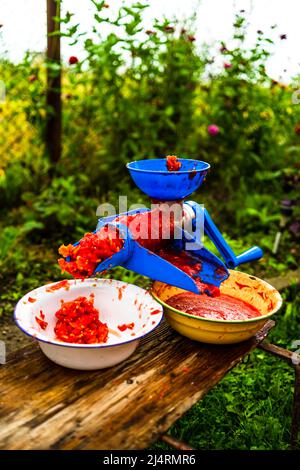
[150,271,282,324]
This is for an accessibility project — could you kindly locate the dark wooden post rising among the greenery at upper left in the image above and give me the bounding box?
[46,0,61,164]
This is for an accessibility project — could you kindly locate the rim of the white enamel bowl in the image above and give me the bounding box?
[13,278,163,349]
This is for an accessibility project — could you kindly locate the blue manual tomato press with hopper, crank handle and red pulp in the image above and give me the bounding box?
[61,157,263,295]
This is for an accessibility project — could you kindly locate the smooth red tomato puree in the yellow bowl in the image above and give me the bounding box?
[166,292,261,320]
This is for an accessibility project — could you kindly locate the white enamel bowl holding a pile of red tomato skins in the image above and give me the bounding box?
[14,279,163,370]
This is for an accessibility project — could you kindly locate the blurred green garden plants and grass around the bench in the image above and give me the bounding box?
[0,1,300,448]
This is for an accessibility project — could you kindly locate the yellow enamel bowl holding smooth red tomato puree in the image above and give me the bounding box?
[152,270,282,344]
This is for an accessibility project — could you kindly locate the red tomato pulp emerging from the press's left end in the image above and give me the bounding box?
[58,226,124,278]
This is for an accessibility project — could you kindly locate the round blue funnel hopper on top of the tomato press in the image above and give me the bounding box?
[126,158,210,201]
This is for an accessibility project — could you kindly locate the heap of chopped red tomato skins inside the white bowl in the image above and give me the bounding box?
[54,297,108,344]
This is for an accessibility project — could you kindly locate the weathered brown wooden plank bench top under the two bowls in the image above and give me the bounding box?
[0,320,274,449]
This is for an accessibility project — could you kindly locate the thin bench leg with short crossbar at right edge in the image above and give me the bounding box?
[258,342,300,450]
